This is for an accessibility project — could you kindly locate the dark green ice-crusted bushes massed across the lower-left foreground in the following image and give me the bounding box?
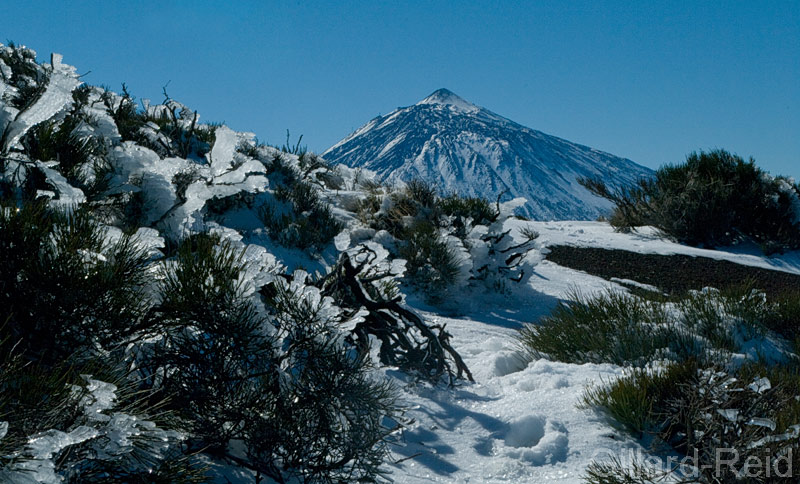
[0,202,394,482]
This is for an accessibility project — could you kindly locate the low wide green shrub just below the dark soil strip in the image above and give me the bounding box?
[519,288,792,367]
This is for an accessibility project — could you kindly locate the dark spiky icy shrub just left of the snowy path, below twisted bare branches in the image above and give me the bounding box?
[245,273,396,482]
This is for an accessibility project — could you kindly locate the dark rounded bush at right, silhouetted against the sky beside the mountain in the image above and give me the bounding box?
[581,150,800,253]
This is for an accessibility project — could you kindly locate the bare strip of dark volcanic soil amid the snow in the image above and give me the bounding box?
[546,245,800,296]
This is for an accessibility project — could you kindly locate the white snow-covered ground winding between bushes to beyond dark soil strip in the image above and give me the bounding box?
[378,221,800,483]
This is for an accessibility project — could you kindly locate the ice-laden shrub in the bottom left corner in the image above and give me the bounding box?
[0,354,200,484]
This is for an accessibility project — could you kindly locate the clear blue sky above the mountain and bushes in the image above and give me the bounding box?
[0,0,800,179]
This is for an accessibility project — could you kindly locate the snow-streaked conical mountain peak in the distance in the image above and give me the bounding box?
[322,89,652,220]
